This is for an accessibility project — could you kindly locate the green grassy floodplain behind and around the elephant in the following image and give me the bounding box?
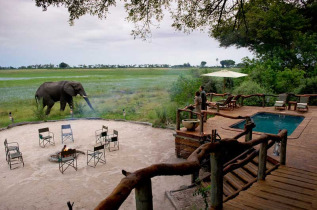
[0,68,190,127]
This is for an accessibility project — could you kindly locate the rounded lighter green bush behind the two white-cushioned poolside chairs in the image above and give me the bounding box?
[276,68,305,93]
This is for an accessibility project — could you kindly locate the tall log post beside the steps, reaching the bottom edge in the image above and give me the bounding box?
[210,150,223,209]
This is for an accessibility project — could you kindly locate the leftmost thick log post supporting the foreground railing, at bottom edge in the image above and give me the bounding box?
[135,179,153,210]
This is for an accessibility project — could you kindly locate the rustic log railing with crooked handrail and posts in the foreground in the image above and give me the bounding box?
[95,116,287,210]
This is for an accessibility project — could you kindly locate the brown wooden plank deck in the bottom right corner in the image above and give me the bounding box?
[224,166,317,210]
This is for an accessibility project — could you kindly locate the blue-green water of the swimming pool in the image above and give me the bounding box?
[230,112,304,136]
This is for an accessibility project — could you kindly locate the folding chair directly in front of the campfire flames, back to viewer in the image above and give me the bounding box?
[58,149,77,174]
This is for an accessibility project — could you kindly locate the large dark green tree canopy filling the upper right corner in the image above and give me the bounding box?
[212,0,317,74]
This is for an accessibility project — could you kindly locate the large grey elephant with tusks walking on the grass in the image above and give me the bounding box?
[35,81,94,115]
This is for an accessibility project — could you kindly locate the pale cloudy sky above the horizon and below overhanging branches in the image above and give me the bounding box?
[0,0,253,67]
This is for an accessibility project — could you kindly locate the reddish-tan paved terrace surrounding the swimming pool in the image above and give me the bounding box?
[181,106,317,171]
